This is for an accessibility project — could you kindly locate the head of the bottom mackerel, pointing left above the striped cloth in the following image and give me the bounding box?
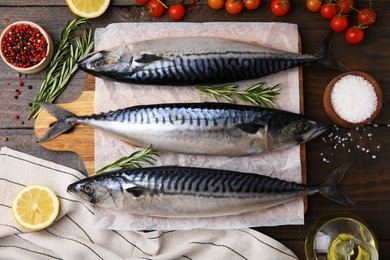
[67,176,120,208]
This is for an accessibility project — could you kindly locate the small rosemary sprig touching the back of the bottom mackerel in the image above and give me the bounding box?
[95,145,159,174]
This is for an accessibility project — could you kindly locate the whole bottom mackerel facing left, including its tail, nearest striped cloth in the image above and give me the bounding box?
[67,165,353,218]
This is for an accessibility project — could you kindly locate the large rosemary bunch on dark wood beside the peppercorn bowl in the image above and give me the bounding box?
[28,18,93,119]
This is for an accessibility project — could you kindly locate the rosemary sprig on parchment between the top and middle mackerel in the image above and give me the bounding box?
[197,82,281,107]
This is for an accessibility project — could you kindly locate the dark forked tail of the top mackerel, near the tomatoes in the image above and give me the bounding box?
[315,31,351,71]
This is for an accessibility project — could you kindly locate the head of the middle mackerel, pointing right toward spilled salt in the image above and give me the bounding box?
[268,113,327,150]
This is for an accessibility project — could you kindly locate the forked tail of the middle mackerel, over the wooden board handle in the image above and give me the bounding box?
[34,101,77,143]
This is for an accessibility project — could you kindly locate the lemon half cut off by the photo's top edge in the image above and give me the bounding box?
[66,0,110,18]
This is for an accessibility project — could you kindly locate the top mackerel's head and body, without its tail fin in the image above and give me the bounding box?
[78,37,322,85]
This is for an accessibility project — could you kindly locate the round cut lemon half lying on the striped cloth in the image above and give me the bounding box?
[12,184,60,230]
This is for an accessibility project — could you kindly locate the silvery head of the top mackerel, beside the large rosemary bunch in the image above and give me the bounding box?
[77,47,132,78]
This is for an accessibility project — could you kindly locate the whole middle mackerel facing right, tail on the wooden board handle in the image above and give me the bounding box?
[40,103,326,156]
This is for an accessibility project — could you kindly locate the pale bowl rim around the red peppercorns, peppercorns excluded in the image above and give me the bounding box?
[0,21,54,74]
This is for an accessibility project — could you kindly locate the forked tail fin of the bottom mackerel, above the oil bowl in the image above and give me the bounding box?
[320,162,356,206]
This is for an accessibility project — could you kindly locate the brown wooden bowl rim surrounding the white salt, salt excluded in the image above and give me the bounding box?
[323,71,383,128]
